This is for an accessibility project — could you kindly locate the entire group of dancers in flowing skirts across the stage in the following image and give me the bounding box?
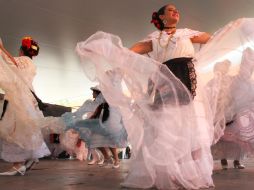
[0,4,254,189]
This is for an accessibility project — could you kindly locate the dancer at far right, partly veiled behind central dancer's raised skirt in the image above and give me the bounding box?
[210,48,254,169]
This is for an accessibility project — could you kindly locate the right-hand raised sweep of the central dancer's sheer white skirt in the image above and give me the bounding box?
[195,18,254,143]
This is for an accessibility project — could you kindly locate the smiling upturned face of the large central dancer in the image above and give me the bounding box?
[160,5,180,24]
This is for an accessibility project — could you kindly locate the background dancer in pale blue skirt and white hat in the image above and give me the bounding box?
[62,85,127,168]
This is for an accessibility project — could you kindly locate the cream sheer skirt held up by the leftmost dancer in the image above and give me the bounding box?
[0,56,44,150]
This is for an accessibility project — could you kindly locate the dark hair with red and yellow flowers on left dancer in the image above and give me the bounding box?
[20,37,40,59]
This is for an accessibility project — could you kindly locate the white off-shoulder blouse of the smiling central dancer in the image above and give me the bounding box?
[144,28,203,62]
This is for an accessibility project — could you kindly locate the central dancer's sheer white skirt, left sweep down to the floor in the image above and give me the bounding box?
[77,32,213,189]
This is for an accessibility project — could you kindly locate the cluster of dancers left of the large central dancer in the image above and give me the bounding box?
[0,37,128,172]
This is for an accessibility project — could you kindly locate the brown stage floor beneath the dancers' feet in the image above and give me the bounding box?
[0,159,254,190]
